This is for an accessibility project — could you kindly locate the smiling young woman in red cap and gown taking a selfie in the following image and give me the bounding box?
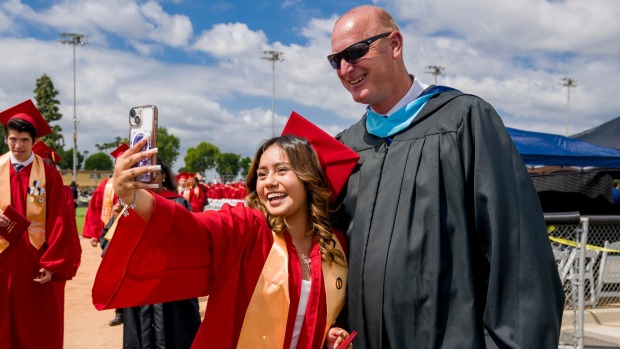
[93,113,358,348]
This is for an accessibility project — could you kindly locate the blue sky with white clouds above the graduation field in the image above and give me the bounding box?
[0,0,620,174]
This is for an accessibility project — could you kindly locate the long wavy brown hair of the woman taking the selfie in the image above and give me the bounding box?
[245,135,344,262]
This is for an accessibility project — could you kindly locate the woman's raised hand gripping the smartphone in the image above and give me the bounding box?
[112,138,161,219]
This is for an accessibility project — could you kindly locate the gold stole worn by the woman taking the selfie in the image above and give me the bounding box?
[237,233,347,349]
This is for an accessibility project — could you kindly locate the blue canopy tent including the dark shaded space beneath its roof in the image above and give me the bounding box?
[507,128,620,215]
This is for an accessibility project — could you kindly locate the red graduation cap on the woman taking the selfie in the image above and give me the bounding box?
[282,112,360,202]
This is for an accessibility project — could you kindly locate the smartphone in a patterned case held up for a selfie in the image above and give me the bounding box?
[129,105,157,183]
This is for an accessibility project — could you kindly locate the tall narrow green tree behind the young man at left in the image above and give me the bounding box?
[33,74,65,154]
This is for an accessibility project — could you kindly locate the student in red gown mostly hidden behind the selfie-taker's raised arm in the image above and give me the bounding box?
[82,143,129,326]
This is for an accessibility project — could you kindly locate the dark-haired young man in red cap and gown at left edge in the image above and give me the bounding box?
[0,100,73,349]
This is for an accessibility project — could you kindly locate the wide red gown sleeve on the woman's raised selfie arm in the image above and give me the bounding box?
[92,195,272,310]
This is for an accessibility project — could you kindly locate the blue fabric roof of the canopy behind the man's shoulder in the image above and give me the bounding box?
[507,128,620,169]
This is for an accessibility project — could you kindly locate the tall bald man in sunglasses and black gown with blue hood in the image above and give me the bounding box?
[328,6,564,348]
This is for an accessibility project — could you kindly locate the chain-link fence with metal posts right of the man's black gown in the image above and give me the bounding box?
[545,213,620,348]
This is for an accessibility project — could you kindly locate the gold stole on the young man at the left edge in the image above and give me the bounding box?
[0,153,47,251]
